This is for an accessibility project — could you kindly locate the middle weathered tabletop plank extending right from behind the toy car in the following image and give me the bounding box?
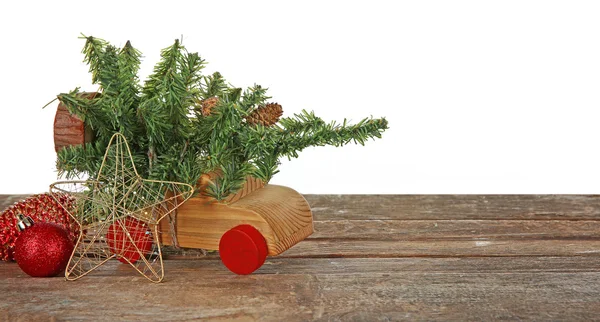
[123,220,600,259]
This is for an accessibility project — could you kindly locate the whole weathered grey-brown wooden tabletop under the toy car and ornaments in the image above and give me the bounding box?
[0,195,600,321]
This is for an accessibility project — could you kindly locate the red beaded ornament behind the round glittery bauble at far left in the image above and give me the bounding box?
[0,193,79,261]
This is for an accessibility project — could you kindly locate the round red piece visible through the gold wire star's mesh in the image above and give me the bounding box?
[106,217,152,264]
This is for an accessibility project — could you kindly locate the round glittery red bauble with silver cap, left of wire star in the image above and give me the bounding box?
[14,222,74,277]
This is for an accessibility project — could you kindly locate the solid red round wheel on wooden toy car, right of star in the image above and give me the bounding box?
[219,225,267,275]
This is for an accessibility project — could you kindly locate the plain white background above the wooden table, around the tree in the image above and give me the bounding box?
[0,0,600,193]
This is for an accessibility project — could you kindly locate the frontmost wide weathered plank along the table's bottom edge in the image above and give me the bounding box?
[0,259,600,321]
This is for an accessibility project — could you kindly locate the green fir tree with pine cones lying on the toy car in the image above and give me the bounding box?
[52,36,388,200]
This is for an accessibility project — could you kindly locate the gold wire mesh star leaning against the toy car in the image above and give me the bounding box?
[50,133,194,282]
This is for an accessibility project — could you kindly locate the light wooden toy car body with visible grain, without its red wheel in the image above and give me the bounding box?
[160,184,313,256]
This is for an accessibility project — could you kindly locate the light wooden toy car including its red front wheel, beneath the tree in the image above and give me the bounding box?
[159,176,313,274]
